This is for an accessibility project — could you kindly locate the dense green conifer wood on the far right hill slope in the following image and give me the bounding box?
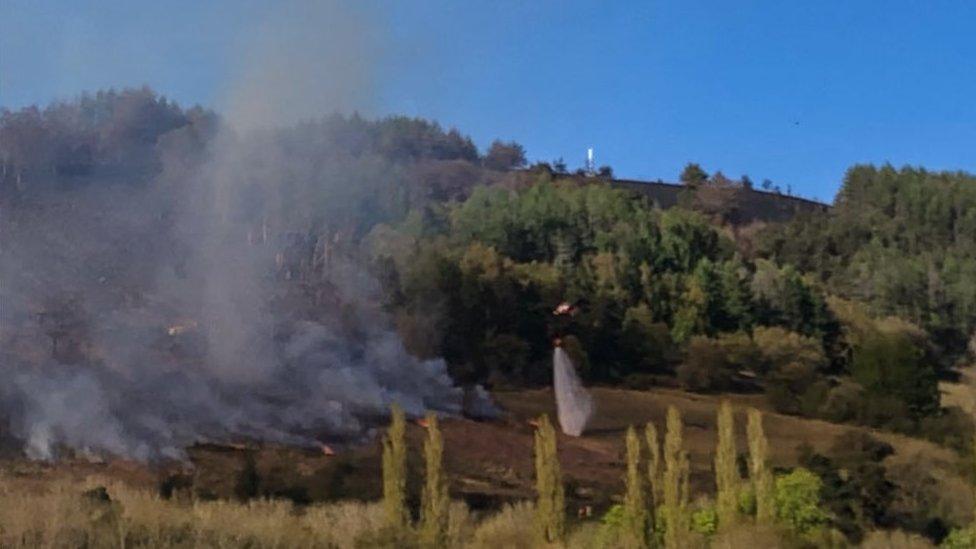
[761,165,976,363]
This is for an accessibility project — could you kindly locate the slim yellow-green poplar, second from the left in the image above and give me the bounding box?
[420,413,450,547]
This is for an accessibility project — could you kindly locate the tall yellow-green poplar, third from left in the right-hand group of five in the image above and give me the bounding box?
[663,406,690,549]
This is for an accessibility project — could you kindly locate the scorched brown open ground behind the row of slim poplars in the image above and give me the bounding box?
[2,388,971,512]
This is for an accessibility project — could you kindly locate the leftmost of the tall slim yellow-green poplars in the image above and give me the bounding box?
[383,404,410,531]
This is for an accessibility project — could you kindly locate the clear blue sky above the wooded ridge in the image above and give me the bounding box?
[0,0,976,200]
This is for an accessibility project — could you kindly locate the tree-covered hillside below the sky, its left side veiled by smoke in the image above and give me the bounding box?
[0,89,976,450]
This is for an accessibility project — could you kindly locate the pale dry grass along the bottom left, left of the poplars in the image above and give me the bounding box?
[0,476,473,549]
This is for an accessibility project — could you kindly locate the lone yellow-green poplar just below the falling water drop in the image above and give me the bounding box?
[535,414,566,542]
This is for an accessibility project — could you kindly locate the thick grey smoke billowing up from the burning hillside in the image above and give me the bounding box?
[0,3,491,460]
